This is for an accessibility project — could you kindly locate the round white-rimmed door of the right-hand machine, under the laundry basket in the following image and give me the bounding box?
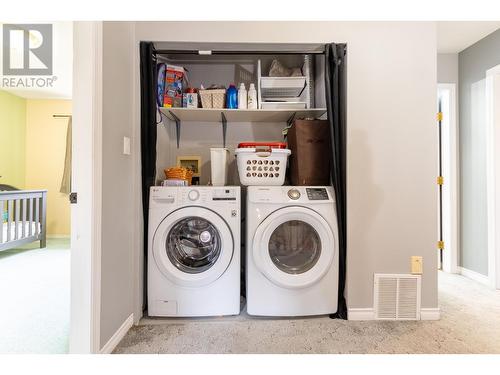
[253,207,336,288]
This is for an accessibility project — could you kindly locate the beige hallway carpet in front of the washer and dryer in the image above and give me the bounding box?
[115,273,500,353]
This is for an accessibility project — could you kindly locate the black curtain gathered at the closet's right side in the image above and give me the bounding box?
[325,43,347,319]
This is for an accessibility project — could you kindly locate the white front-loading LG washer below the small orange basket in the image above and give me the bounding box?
[147,186,241,317]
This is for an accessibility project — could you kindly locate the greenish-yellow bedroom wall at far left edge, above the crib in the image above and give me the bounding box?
[0,90,26,189]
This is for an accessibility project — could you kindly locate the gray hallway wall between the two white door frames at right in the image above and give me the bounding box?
[458,30,500,275]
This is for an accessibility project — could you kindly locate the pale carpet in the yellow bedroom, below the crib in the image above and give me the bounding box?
[0,239,70,354]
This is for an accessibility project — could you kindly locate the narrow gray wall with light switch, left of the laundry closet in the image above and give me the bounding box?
[100,22,136,348]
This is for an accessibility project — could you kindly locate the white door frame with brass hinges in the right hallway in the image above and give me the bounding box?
[437,83,460,273]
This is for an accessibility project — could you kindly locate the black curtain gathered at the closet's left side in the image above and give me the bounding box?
[140,42,156,301]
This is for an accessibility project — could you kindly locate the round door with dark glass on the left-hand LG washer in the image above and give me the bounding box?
[153,207,234,286]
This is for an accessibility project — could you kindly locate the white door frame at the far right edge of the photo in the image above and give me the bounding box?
[486,65,500,289]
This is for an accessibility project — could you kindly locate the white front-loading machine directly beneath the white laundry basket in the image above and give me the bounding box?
[246,186,339,316]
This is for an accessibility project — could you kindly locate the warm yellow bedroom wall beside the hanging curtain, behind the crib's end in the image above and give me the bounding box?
[26,99,71,235]
